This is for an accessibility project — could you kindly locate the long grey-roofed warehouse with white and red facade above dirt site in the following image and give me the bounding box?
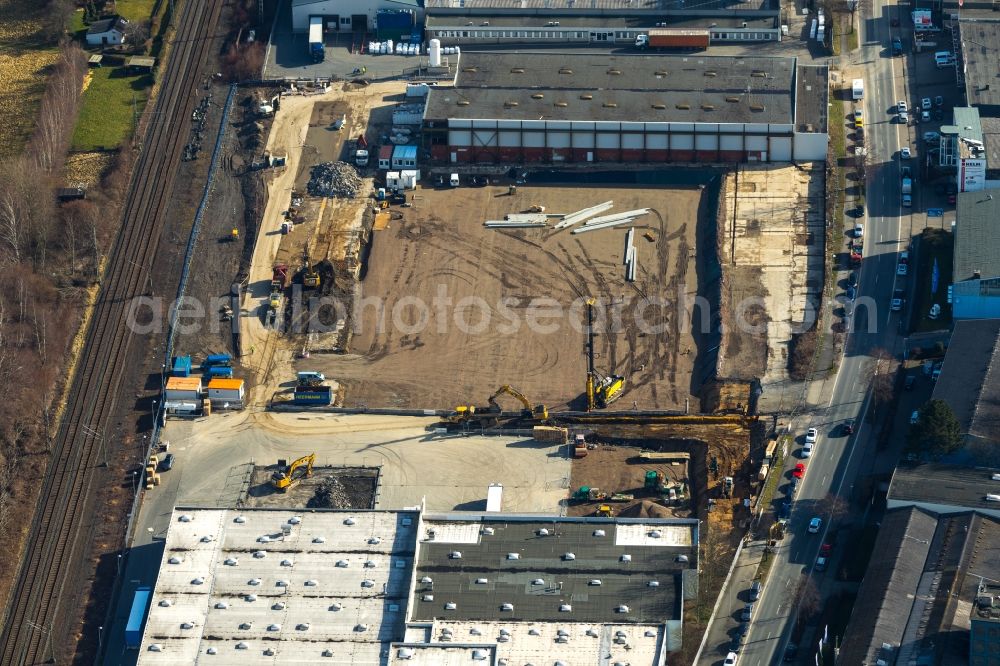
[422,53,828,164]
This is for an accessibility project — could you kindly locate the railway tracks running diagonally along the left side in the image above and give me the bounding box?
[0,0,222,666]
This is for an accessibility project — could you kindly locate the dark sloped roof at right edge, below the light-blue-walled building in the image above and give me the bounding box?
[933,318,1000,444]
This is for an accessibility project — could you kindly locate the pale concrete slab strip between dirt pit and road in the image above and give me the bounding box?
[719,164,824,399]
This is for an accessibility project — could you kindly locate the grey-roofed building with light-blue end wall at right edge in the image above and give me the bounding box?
[952,191,1000,319]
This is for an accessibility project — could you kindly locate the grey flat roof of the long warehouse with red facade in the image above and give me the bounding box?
[424,52,795,124]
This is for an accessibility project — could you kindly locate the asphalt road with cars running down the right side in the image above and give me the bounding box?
[728,0,913,666]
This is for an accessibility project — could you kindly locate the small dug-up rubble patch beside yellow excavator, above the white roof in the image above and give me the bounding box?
[246,465,378,509]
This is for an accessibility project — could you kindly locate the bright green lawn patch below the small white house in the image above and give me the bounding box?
[72,67,153,151]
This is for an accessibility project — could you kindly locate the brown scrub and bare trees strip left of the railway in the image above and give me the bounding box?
[0,0,166,606]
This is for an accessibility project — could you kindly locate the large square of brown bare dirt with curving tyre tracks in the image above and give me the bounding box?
[309,185,701,409]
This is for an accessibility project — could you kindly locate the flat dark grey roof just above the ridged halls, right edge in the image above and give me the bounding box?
[887,462,1000,514]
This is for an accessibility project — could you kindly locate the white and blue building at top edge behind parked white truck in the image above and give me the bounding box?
[292,0,423,34]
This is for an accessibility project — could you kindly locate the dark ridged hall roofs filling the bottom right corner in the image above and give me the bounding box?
[838,507,1000,666]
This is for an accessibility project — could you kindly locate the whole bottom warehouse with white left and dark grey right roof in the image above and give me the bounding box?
[138,508,698,666]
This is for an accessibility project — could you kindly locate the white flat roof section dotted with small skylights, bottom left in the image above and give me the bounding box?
[138,508,419,665]
